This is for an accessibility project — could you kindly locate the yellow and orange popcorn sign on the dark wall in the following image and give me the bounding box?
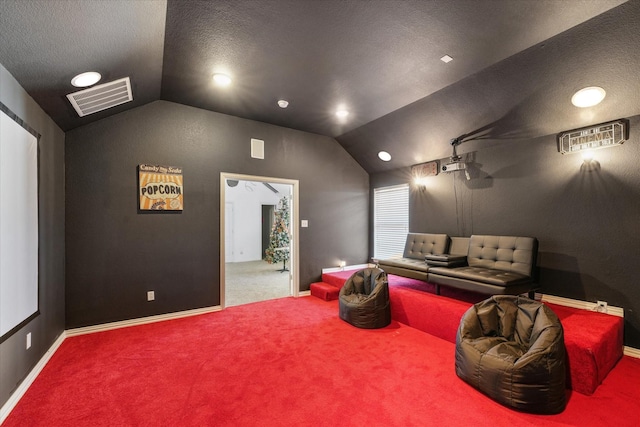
[138,165,184,211]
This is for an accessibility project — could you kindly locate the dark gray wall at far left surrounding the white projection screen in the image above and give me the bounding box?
[0,65,65,406]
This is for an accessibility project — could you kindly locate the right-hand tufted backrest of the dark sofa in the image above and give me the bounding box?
[467,235,538,276]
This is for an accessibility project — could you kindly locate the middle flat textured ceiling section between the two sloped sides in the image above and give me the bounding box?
[162,0,615,136]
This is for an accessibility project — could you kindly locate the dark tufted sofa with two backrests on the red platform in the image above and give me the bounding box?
[378,233,539,297]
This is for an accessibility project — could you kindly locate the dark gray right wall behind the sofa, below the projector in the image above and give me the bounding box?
[371,116,640,348]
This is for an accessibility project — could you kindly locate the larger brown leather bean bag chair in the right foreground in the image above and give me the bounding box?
[456,295,566,414]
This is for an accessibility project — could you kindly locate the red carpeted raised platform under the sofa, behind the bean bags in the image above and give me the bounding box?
[322,271,624,395]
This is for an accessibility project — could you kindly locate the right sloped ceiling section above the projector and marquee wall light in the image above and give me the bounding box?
[337,1,640,173]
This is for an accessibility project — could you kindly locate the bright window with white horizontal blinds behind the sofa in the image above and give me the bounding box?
[373,184,409,259]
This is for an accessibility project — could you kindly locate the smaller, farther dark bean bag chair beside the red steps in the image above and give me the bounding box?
[338,268,391,329]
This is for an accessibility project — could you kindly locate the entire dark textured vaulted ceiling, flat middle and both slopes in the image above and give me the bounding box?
[0,0,640,173]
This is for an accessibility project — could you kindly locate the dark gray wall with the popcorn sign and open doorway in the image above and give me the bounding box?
[65,101,369,328]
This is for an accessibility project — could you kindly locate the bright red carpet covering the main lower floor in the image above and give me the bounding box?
[3,298,640,427]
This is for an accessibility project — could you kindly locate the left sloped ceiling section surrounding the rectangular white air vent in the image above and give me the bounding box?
[0,0,166,131]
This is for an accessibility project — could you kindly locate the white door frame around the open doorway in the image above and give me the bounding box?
[220,172,300,309]
